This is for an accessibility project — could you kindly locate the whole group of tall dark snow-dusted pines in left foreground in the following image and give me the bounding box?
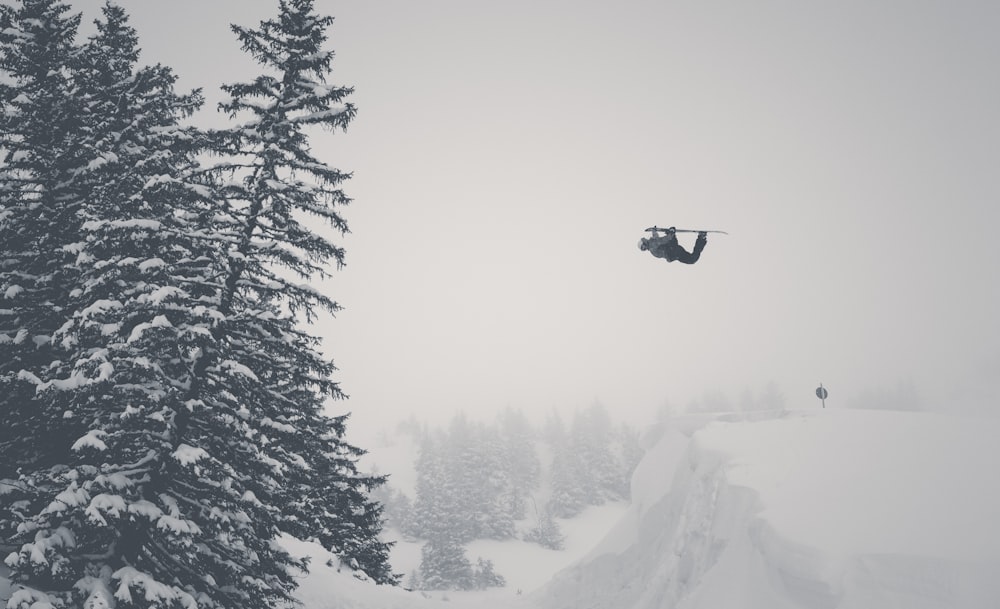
[0,0,396,609]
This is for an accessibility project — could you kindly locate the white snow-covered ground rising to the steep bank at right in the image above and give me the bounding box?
[0,409,1000,609]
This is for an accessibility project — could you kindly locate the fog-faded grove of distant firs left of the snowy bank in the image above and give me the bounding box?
[374,403,642,590]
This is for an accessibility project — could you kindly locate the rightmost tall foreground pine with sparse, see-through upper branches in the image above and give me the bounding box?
[207,0,396,583]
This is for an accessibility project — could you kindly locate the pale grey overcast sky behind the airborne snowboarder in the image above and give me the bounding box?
[71,0,1000,426]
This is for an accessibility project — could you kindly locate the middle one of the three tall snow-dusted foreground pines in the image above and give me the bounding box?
[6,5,308,608]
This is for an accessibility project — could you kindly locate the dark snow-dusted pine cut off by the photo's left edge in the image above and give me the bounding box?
[0,0,83,484]
